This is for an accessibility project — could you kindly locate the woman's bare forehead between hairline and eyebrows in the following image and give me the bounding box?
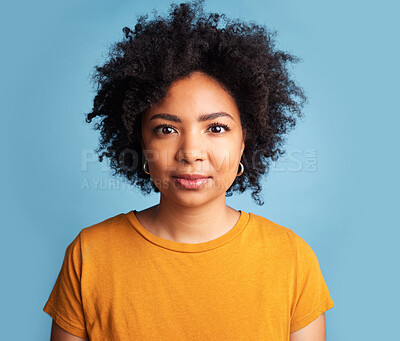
[146,72,239,120]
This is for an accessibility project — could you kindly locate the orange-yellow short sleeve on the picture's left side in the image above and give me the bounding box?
[43,233,89,339]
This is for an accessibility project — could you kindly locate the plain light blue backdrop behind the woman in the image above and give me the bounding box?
[0,0,400,341]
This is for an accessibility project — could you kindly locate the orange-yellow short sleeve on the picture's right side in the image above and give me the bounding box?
[290,234,334,333]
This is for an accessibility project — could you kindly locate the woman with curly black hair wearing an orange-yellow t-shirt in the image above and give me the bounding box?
[43,1,334,341]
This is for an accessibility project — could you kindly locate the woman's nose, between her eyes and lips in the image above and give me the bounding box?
[176,132,205,163]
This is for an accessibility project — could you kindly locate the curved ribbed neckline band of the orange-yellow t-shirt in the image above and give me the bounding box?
[126,210,250,252]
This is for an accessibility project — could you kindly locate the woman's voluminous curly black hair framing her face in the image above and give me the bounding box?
[85,0,307,205]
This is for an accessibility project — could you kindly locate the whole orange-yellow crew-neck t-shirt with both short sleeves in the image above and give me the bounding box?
[43,210,334,341]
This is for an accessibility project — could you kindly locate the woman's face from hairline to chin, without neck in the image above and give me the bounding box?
[141,72,246,207]
